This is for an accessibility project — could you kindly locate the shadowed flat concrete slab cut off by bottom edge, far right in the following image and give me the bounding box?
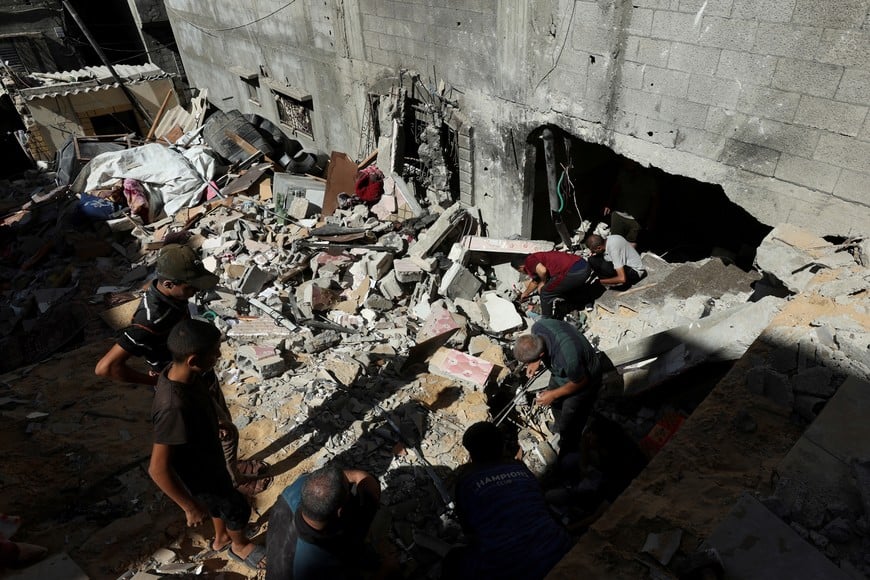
[707,495,849,580]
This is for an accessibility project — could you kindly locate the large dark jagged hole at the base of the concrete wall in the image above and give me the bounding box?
[526,127,771,268]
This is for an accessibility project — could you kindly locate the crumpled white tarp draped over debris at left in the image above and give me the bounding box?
[84,143,216,216]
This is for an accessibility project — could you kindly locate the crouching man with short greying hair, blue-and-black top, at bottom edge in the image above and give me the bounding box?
[266,464,392,580]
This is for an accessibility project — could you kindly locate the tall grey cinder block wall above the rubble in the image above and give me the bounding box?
[166,0,870,235]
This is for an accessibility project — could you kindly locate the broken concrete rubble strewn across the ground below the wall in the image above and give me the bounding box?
[2,80,870,569]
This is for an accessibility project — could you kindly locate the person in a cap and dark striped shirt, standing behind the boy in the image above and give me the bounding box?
[94,244,271,495]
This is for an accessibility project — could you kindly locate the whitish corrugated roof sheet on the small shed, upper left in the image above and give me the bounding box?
[20,63,172,101]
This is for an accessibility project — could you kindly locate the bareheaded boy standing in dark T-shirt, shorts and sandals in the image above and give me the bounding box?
[148,320,265,569]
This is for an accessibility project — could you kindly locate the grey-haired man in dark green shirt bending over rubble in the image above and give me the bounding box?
[514,318,601,459]
